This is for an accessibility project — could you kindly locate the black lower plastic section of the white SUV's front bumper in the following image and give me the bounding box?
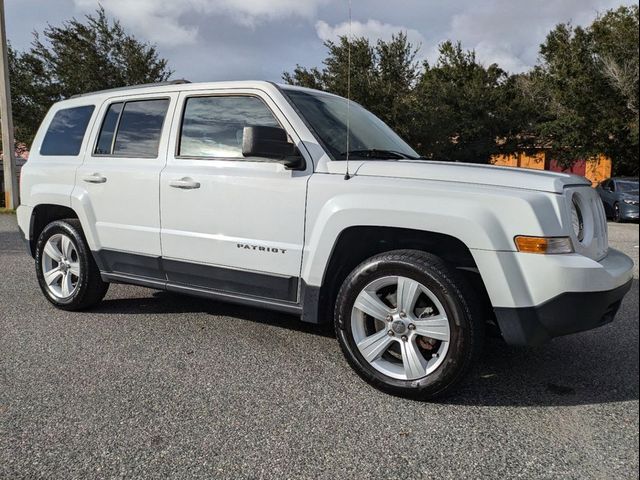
[494,280,633,346]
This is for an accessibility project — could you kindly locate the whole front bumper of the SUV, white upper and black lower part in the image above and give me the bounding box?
[473,248,634,345]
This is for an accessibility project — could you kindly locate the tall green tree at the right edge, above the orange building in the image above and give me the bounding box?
[521,6,638,175]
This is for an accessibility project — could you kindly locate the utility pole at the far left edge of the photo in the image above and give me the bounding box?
[0,0,19,208]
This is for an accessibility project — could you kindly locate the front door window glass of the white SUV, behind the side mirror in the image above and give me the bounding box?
[178,96,280,158]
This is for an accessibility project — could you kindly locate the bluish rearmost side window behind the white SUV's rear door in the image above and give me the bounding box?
[40,105,94,156]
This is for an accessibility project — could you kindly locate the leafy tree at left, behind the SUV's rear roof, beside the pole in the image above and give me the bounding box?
[4,7,172,144]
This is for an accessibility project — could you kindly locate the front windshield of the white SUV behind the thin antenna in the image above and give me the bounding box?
[283,88,420,160]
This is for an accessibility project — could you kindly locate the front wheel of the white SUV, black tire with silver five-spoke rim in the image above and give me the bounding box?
[334,250,484,399]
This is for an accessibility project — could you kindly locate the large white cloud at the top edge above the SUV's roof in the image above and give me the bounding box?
[73,0,330,46]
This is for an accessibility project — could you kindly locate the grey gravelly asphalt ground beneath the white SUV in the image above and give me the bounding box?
[0,215,638,479]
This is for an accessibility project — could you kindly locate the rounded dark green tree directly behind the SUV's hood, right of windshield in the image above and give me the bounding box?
[417,42,529,163]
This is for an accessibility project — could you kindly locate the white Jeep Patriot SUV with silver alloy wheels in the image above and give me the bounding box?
[18,82,633,398]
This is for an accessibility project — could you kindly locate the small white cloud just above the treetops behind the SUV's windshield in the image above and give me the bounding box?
[316,19,424,47]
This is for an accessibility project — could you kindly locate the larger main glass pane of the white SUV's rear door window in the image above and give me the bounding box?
[112,99,169,157]
